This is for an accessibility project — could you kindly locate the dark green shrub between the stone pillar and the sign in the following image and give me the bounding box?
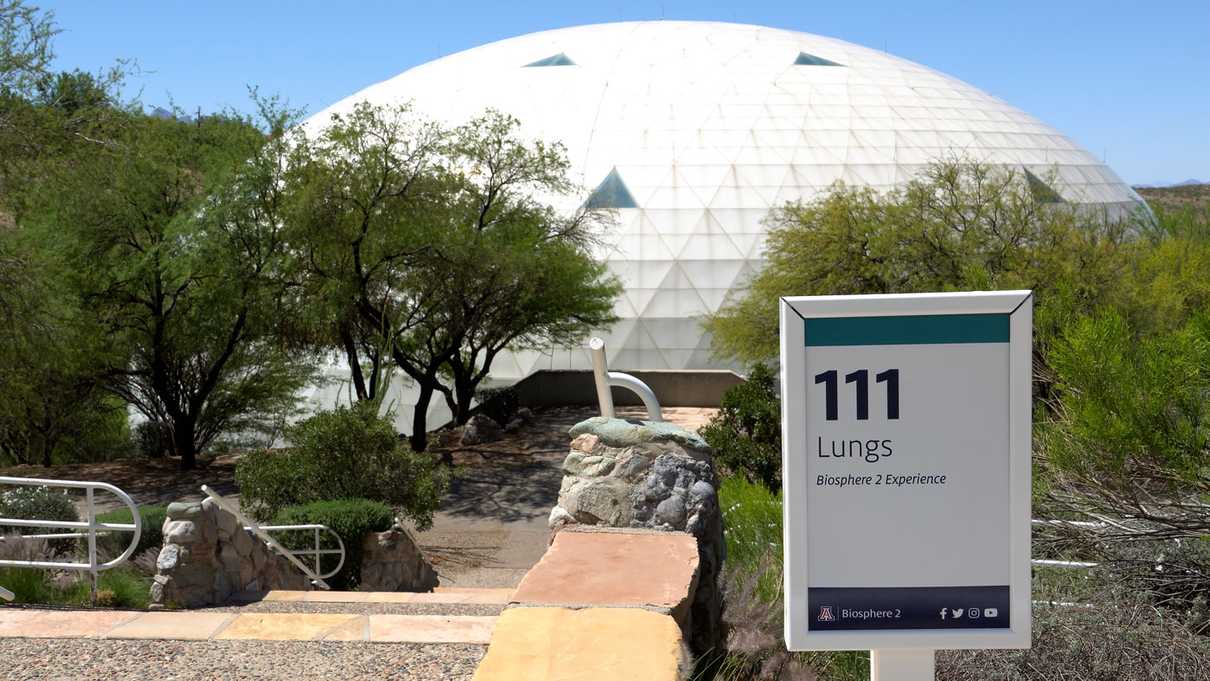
[701,363,782,491]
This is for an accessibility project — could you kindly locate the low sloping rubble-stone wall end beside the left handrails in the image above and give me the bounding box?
[151,500,311,607]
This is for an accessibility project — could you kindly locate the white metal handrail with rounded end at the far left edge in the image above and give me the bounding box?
[0,477,143,600]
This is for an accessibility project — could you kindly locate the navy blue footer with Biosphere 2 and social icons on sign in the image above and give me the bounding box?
[807,585,1009,631]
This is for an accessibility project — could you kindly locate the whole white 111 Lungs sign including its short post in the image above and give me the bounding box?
[780,290,1033,681]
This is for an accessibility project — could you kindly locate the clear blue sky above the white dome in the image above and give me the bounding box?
[42,0,1210,183]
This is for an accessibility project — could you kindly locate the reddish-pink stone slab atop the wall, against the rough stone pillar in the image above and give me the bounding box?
[513,530,697,617]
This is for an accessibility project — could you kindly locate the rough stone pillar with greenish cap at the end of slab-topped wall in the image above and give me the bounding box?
[549,416,726,654]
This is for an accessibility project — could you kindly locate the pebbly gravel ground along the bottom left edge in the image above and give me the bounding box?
[0,639,486,681]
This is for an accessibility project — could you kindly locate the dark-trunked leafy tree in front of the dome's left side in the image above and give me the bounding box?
[287,103,620,440]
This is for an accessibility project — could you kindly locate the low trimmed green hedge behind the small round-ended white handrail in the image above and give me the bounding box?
[273,498,394,590]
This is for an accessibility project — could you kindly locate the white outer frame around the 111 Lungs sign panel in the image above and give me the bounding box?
[779,290,1033,651]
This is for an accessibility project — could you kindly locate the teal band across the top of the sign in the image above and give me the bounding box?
[803,314,1008,347]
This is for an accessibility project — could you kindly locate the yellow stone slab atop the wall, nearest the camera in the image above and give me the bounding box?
[474,607,690,681]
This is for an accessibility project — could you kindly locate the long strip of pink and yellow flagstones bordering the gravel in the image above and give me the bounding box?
[0,608,496,645]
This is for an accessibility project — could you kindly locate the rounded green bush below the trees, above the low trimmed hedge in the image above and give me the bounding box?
[236,405,449,529]
